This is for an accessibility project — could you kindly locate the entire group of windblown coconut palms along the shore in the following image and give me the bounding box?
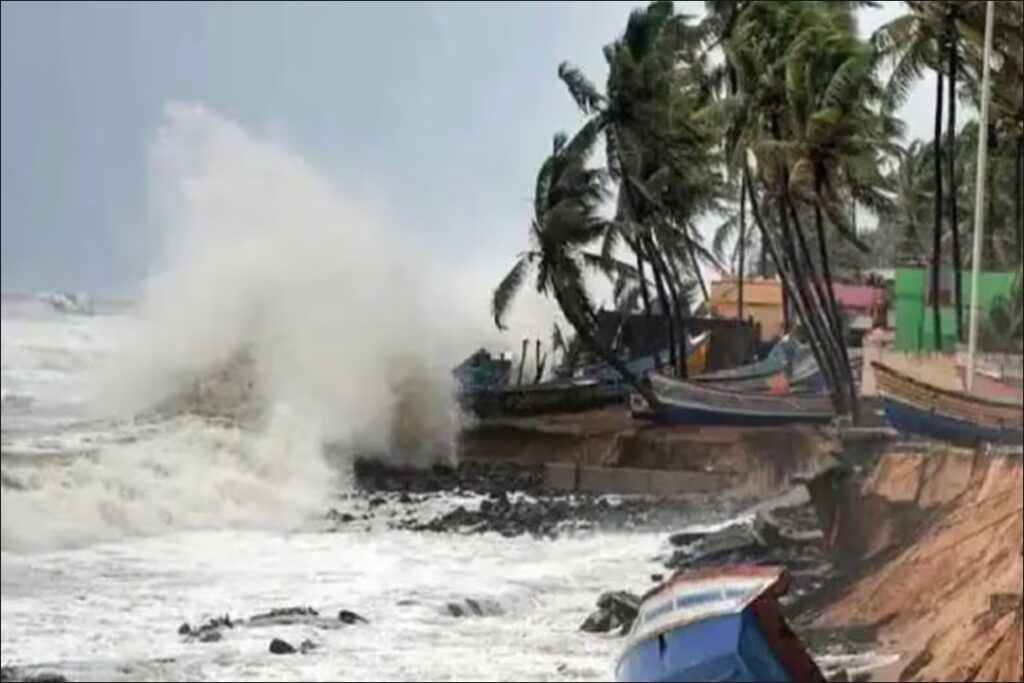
[493,0,1024,418]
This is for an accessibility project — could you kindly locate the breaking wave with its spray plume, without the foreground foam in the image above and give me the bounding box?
[2,104,520,551]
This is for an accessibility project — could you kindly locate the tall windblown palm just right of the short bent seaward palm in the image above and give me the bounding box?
[558,0,717,377]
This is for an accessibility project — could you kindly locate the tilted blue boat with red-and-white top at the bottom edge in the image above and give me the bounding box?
[615,566,825,682]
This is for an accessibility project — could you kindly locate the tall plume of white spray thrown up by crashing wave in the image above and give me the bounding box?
[128,104,470,455]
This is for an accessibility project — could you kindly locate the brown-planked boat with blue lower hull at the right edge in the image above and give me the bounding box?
[871,362,1024,445]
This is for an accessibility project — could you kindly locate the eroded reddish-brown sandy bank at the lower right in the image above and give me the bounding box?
[819,450,1024,681]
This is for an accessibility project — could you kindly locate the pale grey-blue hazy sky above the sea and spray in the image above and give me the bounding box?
[0,2,932,293]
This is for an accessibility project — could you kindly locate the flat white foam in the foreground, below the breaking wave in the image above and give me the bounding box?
[2,531,664,680]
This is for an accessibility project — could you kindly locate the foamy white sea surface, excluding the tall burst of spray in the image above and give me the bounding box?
[0,300,683,680]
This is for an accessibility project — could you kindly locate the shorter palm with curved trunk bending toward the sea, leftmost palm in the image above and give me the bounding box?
[492,124,657,407]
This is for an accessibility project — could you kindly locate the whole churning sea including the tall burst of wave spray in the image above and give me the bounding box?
[0,104,706,680]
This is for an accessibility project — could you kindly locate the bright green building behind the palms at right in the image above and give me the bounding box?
[892,268,1017,351]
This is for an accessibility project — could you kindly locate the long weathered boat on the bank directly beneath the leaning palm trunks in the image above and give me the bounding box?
[630,373,835,427]
